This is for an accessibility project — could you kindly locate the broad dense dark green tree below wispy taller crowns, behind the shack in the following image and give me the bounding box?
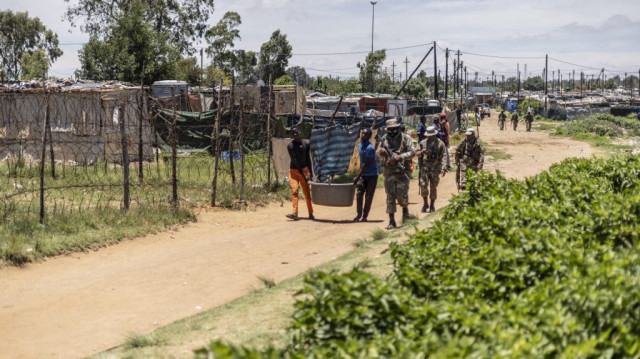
[76,0,180,83]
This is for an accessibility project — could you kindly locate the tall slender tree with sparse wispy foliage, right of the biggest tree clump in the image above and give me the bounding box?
[205,11,242,72]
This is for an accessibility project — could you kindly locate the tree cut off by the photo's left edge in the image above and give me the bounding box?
[0,10,62,80]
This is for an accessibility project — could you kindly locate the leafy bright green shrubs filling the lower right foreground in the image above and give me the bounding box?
[197,155,640,358]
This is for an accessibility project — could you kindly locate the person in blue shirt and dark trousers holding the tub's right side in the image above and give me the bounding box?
[353,128,378,222]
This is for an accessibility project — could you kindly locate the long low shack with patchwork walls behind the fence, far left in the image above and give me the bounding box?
[0,83,153,164]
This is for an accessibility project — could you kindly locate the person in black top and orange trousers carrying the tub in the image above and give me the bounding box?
[287,127,315,220]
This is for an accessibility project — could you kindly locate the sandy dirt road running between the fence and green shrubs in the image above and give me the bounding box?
[0,115,593,358]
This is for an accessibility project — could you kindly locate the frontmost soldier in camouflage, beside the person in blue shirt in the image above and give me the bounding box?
[376,119,415,229]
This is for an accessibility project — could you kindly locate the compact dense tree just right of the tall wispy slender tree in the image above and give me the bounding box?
[258,30,292,82]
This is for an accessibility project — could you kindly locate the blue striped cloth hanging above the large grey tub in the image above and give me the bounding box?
[309,123,360,182]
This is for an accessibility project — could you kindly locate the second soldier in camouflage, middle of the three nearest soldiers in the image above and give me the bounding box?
[416,126,447,213]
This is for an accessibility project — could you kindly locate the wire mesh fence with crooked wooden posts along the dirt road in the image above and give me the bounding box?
[0,88,275,228]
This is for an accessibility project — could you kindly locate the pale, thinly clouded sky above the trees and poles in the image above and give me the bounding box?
[0,0,640,80]
